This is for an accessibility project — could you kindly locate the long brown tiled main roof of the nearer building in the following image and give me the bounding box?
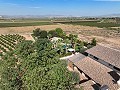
[74,57,118,90]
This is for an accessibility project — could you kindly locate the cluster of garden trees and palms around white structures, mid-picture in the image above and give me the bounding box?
[33,28,97,57]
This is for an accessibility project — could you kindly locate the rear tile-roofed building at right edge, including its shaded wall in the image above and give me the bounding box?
[86,45,120,73]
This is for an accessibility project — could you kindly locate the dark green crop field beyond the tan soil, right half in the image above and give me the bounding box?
[56,21,120,28]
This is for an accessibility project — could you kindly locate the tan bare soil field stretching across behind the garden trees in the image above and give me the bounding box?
[0,24,120,47]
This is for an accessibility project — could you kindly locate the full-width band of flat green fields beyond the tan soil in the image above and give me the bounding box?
[0,19,120,28]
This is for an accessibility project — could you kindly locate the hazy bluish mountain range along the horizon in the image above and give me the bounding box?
[0,13,120,19]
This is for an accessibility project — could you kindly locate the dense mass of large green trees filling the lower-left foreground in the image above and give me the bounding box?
[0,39,79,90]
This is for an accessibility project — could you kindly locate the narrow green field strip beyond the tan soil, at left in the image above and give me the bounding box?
[0,22,53,27]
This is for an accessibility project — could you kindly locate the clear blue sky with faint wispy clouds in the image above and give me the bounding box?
[0,0,120,16]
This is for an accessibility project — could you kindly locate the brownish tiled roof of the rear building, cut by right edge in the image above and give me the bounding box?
[86,45,120,68]
